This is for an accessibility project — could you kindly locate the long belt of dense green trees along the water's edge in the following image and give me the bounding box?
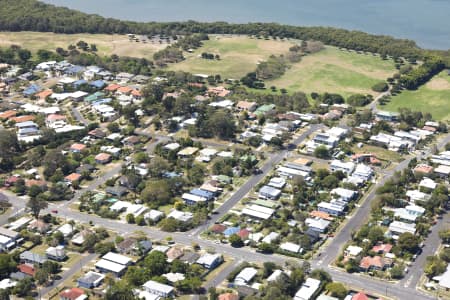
[0,0,442,63]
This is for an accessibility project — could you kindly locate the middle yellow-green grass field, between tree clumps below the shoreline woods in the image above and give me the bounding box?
[169,36,293,79]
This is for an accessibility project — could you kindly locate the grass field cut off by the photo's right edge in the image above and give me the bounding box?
[378,71,450,121]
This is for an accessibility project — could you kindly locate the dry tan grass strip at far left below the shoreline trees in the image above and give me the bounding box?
[0,31,167,59]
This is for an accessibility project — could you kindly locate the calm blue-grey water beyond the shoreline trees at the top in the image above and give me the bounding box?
[44,0,450,49]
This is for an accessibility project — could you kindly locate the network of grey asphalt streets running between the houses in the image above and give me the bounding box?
[1,125,450,300]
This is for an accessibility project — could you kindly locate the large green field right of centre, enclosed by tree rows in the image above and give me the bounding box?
[266,47,395,96]
